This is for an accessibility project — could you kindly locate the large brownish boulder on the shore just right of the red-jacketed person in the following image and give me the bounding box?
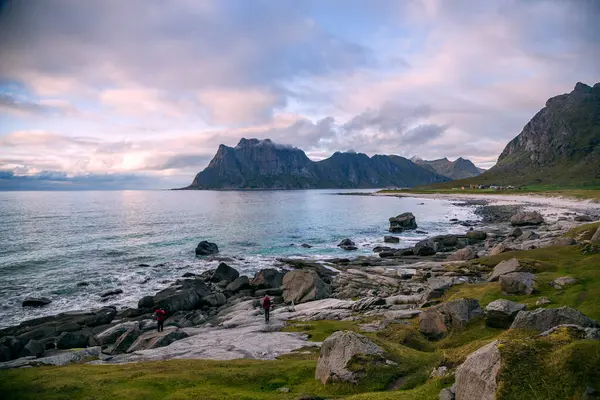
[283,270,331,304]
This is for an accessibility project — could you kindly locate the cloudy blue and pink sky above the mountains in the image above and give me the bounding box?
[0,0,600,190]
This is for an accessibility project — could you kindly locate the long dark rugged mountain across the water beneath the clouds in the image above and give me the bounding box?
[186,139,448,189]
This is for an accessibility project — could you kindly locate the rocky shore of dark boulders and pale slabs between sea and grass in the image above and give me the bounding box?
[0,198,600,399]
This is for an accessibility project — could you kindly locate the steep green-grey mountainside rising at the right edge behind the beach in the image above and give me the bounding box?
[424,82,600,187]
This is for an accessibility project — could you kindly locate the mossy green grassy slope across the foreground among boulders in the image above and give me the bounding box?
[0,223,600,400]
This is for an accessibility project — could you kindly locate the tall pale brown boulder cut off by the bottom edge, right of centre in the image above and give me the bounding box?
[455,341,502,400]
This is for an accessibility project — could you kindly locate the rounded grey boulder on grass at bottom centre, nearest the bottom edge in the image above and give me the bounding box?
[315,331,384,384]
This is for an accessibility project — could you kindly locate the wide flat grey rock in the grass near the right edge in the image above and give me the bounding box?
[510,307,598,332]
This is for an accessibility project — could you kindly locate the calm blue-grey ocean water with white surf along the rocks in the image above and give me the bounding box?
[0,190,477,326]
